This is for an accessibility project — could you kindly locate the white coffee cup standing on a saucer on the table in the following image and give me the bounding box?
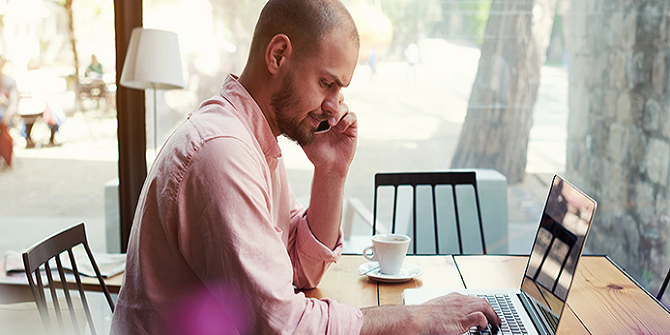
[363,234,412,275]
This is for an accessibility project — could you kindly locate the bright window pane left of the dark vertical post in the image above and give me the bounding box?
[0,0,118,255]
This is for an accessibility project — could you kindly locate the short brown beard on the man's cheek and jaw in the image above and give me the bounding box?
[270,71,324,146]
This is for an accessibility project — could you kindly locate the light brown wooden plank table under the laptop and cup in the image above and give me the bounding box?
[304,255,670,334]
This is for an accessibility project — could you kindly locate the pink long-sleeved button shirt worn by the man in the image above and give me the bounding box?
[112,76,363,334]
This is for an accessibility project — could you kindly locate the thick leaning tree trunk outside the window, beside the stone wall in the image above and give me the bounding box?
[451,0,557,183]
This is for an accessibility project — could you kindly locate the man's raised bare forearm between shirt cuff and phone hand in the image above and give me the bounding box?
[307,170,346,250]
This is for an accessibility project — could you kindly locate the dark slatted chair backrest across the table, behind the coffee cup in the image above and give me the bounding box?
[372,171,486,254]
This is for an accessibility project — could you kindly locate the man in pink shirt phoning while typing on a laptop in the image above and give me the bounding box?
[112,0,499,334]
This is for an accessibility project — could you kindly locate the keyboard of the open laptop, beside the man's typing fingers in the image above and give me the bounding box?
[470,294,528,335]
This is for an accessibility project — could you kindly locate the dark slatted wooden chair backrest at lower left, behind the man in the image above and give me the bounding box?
[23,223,114,335]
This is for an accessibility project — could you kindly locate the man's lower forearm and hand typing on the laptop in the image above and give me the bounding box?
[361,293,501,335]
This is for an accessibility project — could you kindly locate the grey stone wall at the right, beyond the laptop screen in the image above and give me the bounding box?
[565,0,670,294]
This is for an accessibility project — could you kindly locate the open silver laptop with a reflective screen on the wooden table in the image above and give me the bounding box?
[403,175,597,335]
